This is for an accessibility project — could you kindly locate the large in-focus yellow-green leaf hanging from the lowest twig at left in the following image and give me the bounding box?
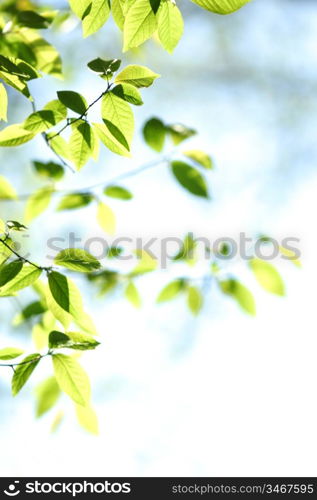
[52,354,90,406]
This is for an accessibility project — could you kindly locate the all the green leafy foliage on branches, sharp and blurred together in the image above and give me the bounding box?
[0,0,296,434]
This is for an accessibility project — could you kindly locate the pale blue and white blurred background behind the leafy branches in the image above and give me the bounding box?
[0,0,317,476]
